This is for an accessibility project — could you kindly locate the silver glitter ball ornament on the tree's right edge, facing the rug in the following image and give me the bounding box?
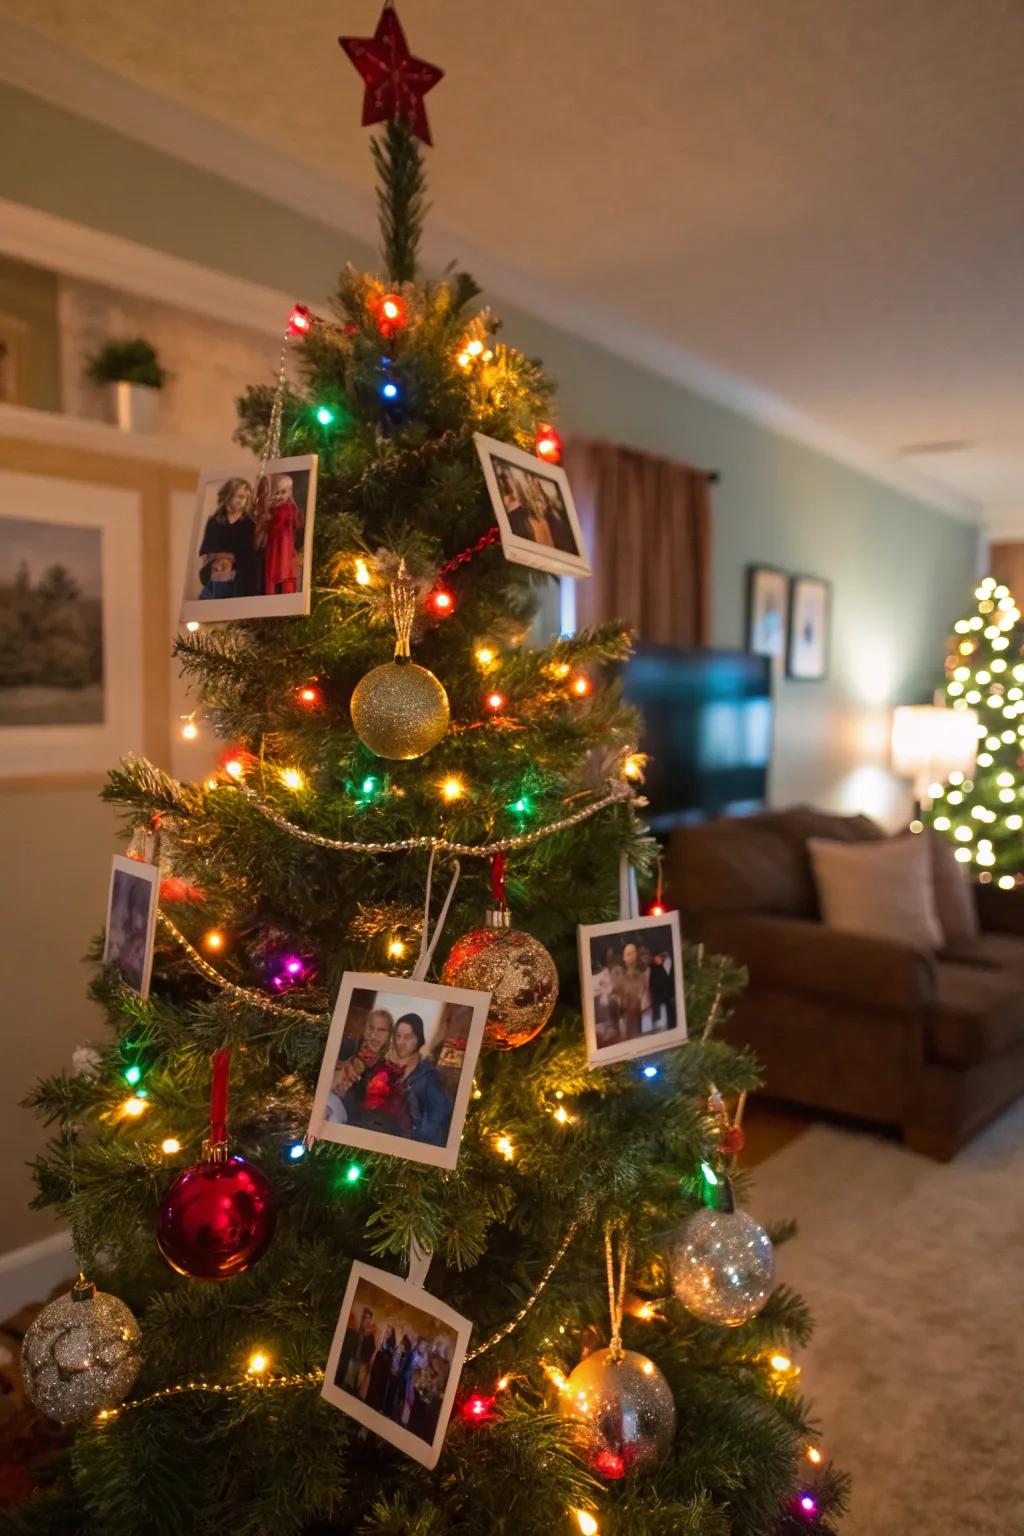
[668,1210,775,1329]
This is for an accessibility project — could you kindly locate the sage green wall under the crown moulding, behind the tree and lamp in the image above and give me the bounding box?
[0,86,978,816]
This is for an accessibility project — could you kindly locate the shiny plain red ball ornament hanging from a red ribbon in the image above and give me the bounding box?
[157,1157,278,1279]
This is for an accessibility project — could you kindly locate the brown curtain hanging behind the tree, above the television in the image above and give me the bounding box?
[563,438,711,645]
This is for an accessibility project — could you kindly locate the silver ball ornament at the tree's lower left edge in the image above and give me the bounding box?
[21,1279,143,1424]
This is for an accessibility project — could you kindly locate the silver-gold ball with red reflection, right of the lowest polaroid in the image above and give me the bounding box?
[559,1349,676,1481]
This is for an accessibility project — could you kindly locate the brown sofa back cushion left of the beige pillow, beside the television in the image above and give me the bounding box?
[665,816,815,917]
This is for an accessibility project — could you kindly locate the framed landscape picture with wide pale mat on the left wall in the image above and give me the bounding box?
[0,472,143,779]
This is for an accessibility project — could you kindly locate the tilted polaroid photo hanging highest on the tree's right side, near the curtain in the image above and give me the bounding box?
[473,432,591,576]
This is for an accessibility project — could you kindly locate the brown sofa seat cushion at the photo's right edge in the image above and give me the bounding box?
[924,962,1024,1069]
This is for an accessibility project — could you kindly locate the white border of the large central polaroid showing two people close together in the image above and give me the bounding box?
[309,971,491,1169]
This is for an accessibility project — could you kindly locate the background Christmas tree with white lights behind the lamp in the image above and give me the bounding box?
[921,576,1024,889]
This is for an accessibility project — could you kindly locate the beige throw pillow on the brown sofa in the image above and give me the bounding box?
[808,834,944,949]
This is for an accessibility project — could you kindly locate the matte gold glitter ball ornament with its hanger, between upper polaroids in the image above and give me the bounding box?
[350,561,450,762]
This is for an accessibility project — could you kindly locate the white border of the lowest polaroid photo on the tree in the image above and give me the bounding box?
[321,1260,473,1467]
